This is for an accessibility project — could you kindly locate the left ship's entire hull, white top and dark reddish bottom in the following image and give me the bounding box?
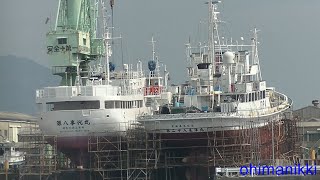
[39,107,149,164]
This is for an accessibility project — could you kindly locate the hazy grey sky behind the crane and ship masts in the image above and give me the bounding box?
[0,0,320,109]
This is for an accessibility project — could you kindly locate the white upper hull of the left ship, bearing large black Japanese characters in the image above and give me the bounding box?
[39,107,149,137]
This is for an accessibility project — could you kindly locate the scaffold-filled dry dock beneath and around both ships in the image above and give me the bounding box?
[8,111,317,180]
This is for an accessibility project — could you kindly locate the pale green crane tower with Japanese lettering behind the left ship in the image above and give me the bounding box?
[47,0,106,86]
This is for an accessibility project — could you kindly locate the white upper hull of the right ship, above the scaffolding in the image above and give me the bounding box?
[138,111,283,134]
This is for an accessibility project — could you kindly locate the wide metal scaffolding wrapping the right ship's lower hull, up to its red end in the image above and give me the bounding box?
[88,116,299,180]
